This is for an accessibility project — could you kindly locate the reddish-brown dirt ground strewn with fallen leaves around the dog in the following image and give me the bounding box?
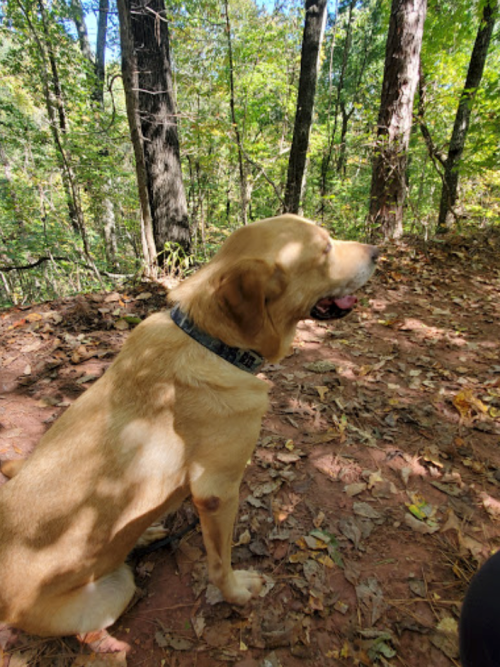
[0,232,500,667]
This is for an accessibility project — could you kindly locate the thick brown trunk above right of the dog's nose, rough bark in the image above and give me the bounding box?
[369,0,427,238]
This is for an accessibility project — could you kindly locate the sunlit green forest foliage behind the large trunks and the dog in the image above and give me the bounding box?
[0,0,500,306]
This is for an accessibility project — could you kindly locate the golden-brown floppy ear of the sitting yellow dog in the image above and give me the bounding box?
[216,259,287,339]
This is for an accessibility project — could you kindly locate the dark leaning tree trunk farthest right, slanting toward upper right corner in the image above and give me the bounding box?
[436,0,498,233]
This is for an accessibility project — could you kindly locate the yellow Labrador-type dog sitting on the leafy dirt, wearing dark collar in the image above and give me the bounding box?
[0,214,378,648]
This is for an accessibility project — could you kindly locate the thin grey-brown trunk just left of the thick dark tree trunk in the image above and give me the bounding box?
[117,0,156,273]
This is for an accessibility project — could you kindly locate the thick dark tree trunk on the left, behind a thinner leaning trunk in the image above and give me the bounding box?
[124,0,191,253]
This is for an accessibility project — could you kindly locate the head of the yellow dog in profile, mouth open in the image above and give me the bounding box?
[171,214,378,361]
